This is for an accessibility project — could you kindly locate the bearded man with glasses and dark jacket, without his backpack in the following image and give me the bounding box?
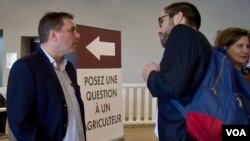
[142,2,211,141]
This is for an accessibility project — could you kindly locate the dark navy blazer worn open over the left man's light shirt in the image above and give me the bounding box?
[7,48,86,141]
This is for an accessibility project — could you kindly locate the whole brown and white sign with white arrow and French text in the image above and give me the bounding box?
[76,25,124,141]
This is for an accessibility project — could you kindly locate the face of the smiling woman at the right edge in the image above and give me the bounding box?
[226,36,250,68]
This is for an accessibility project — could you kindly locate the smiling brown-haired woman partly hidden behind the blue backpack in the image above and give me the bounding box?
[215,27,250,85]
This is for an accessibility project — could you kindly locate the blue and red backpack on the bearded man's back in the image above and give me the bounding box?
[171,49,250,141]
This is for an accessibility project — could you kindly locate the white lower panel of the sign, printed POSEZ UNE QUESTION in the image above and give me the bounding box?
[77,68,123,141]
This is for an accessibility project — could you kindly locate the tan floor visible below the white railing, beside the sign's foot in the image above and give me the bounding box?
[0,125,158,141]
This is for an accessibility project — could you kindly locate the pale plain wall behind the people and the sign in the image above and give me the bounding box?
[0,0,250,86]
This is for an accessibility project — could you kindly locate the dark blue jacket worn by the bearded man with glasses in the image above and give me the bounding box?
[147,25,211,141]
